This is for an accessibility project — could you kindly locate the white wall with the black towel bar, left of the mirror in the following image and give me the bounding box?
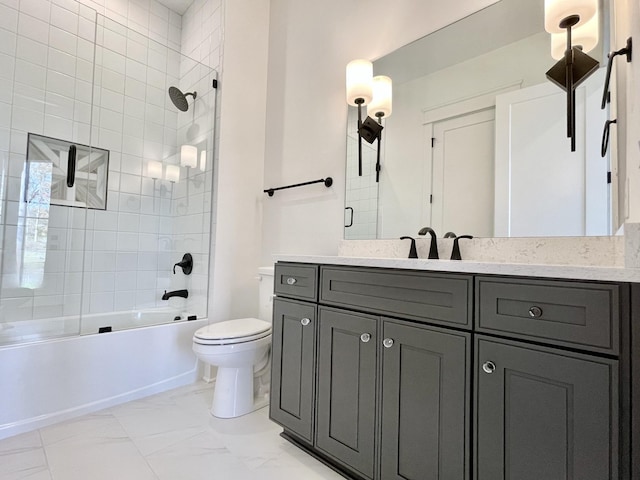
[262,0,494,264]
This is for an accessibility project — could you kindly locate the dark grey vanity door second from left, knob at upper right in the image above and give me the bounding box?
[316,307,377,478]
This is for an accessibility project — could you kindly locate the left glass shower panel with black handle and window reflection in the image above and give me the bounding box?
[0,0,96,345]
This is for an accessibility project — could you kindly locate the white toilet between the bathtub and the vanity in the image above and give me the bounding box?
[193,267,273,418]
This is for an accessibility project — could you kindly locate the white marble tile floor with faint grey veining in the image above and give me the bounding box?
[0,382,342,480]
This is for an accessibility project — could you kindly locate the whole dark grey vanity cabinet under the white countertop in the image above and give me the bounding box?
[271,263,640,480]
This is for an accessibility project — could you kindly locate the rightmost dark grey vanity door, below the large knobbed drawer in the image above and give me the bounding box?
[475,337,618,480]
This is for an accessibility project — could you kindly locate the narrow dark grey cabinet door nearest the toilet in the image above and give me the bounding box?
[269,298,316,443]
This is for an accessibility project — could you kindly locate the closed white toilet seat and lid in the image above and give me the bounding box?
[193,318,271,345]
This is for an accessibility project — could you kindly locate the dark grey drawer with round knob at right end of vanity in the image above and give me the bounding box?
[476,277,620,354]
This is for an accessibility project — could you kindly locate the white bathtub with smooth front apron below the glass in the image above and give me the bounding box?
[0,309,208,439]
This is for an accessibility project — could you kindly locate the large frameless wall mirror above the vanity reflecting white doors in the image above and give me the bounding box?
[345,0,618,239]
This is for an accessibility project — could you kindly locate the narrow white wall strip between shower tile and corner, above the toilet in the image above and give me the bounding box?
[209,0,269,321]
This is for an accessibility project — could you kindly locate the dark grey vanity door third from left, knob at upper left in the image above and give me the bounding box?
[381,320,470,480]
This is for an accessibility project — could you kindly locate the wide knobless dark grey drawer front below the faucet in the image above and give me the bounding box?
[320,266,473,328]
